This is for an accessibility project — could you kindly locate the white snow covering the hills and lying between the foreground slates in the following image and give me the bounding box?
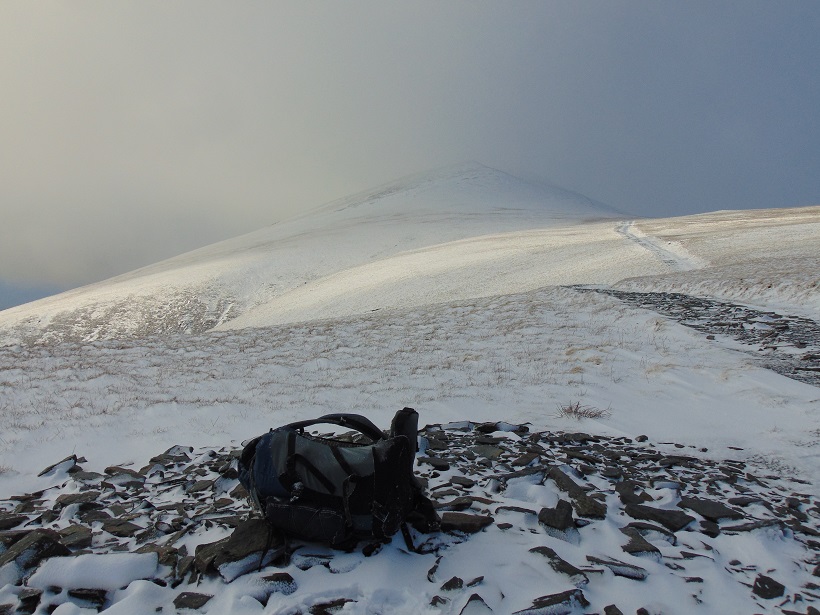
[0,165,820,614]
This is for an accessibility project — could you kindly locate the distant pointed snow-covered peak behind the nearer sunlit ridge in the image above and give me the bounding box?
[0,164,620,343]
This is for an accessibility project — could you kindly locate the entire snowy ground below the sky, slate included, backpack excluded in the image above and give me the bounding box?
[0,165,820,615]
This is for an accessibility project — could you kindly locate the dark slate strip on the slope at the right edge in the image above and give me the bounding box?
[578,287,820,386]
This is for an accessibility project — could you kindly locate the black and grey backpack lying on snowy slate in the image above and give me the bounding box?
[239,408,439,548]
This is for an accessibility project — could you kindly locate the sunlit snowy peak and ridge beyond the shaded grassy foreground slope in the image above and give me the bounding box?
[0,163,820,344]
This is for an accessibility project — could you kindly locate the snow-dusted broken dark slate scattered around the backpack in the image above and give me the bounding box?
[0,422,820,615]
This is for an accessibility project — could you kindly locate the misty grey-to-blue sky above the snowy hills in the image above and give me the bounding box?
[0,0,820,309]
